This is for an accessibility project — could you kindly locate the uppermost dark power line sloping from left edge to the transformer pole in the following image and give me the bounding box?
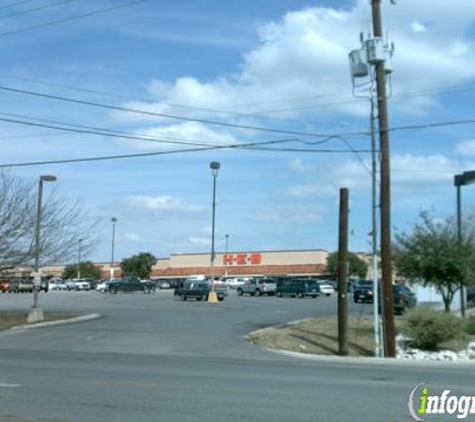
[0,86,368,138]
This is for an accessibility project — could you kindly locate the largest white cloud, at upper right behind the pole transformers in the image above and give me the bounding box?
[118,0,475,126]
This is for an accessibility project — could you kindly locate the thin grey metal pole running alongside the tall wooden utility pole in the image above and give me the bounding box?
[370,95,382,357]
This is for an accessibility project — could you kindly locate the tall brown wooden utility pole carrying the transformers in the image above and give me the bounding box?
[371,0,396,357]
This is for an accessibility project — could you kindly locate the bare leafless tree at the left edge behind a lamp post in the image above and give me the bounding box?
[0,172,97,275]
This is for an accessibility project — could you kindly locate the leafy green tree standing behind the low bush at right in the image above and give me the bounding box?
[394,212,475,312]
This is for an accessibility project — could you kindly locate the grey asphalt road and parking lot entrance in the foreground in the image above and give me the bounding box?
[0,291,474,422]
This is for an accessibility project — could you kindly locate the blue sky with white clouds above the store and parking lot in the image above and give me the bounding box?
[0,0,475,261]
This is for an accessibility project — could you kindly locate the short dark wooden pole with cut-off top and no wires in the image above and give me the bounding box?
[338,188,350,356]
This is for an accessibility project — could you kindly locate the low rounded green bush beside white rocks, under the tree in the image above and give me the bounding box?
[403,308,463,350]
